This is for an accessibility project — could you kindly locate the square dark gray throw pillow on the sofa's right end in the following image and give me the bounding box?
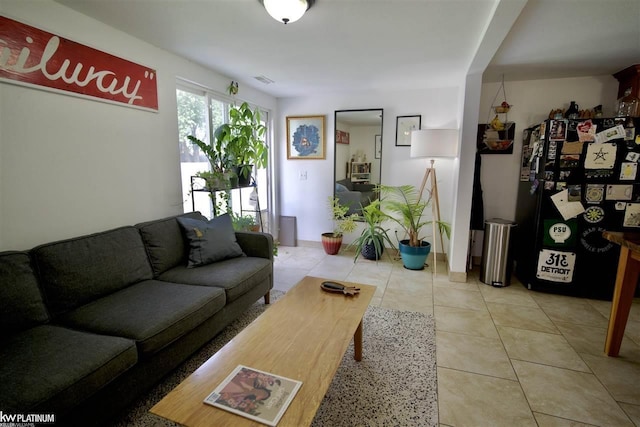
[177,214,243,268]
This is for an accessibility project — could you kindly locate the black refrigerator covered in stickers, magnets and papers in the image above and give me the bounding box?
[512,117,640,300]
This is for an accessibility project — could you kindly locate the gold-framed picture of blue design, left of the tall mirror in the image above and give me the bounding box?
[287,116,325,160]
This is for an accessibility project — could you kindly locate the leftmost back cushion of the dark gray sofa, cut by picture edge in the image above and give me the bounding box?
[0,251,49,339]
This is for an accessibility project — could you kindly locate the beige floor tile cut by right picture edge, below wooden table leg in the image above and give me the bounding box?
[582,354,640,405]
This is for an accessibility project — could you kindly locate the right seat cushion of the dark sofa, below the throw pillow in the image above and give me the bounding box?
[159,257,273,303]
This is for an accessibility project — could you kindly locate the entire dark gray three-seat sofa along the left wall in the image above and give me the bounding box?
[0,212,273,426]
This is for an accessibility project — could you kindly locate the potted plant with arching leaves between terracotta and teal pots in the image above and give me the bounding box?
[349,200,394,262]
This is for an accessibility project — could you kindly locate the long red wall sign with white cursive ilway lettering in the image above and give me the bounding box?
[0,16,158,111]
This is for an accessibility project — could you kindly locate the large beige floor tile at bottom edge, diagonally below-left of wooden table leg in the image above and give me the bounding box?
[512,360,633,427]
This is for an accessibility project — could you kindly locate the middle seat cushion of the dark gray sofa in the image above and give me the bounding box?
[60,280,225,356]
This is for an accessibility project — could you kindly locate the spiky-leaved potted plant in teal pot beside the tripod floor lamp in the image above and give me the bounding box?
[380,185,451,270]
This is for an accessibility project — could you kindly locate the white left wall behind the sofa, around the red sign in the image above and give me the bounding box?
[0,0,276,250]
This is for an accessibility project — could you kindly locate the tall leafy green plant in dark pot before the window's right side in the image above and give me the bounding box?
[216,102,267,186]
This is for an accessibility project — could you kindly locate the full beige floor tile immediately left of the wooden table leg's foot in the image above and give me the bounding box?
[497,326,591,372]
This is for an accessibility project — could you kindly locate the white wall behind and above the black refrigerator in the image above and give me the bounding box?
[478,76,618,224]
